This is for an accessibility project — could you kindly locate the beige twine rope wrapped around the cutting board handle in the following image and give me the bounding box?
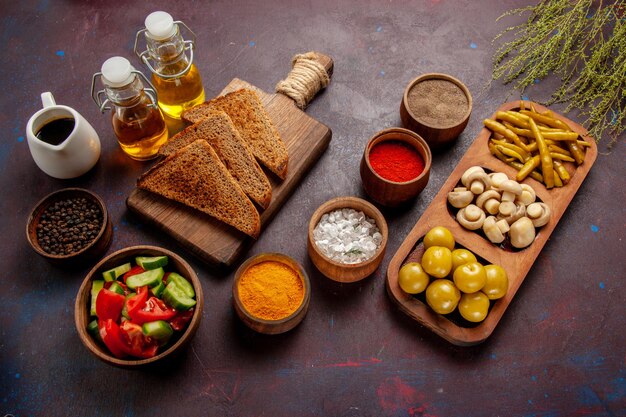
[276,52,330,109]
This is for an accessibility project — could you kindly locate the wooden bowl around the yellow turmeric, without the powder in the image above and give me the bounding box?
[233,253,311,334]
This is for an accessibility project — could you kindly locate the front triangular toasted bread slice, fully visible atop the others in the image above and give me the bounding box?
[137,140,261,239]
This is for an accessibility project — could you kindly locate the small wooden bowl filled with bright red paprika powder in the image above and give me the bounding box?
[360,128,432,207]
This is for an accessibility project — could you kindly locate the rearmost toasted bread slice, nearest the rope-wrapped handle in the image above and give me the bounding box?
[182,89,289,179]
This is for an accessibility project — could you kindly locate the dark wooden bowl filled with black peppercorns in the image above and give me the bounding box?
[26,188,113,266]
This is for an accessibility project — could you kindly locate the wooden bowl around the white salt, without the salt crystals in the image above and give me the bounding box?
[307,197,389,282]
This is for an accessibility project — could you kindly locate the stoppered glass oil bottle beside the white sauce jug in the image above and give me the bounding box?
[91,56,169,161]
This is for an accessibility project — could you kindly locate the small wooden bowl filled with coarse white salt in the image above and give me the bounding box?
[307,197,389,282]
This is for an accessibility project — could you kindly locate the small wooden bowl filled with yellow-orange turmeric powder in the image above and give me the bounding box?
[233,253,311,334]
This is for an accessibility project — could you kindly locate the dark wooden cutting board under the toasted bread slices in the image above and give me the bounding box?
[126,54,333,268]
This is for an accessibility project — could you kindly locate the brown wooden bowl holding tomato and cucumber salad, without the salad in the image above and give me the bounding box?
[74,246,204,368]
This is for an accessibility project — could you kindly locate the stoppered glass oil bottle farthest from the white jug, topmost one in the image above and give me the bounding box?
[135,11,204,119]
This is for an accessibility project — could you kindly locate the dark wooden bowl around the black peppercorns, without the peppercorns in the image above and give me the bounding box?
[26,188,113,266]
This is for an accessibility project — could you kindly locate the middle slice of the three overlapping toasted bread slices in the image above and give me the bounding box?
[159,111,272,209]
